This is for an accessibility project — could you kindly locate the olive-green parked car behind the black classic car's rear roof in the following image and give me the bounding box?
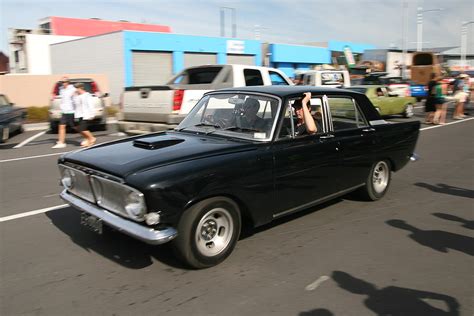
[348,85,416,117]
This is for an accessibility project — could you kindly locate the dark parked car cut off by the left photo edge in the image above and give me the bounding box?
[0,94,26,143]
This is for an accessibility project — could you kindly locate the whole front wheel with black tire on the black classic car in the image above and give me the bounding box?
[173,197,241,269]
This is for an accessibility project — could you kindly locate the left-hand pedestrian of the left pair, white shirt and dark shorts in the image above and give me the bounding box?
[52,77,76,149]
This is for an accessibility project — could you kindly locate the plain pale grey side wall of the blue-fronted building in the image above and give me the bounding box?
[51,32,125,104]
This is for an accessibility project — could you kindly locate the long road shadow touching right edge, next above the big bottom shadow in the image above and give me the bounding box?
[386,219,474,256]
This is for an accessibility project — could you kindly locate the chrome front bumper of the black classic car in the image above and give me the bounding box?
[60,190,178,245]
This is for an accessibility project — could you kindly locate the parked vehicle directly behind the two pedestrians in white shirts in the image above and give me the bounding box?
[49,78,109,132]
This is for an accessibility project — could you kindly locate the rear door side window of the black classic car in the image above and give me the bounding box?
[328,97,367,131]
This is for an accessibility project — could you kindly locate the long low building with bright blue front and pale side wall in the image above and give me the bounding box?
[51,31,373,103]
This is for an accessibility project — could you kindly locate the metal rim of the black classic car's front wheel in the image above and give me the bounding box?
[195,208,234,257]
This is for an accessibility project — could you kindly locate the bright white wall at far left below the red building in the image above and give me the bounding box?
[25,34,81,75]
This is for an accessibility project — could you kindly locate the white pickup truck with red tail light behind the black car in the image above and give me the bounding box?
[118,65,293,134]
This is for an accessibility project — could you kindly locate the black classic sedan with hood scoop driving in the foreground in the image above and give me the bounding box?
[59,86,419,268]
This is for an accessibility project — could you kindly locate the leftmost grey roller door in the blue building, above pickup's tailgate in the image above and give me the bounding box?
[132,52,173,86]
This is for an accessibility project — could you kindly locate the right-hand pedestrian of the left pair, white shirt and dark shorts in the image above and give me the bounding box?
[74,83,96,147]
